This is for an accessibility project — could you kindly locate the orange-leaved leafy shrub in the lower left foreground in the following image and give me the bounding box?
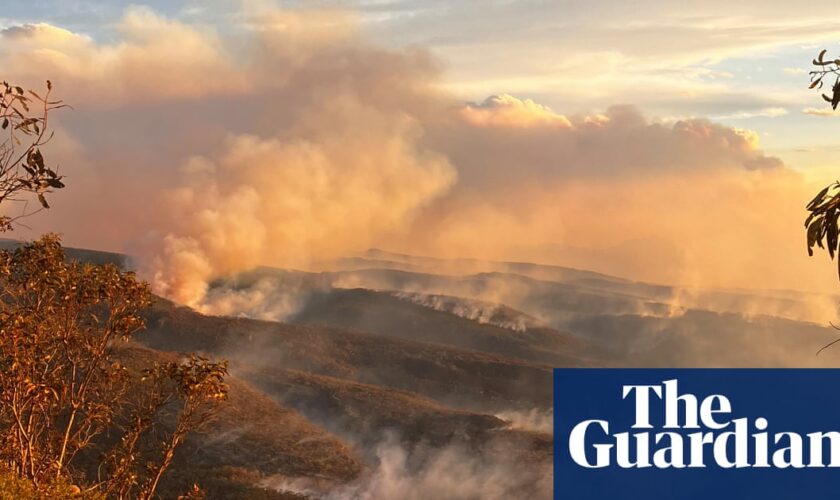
[0,236,227,499]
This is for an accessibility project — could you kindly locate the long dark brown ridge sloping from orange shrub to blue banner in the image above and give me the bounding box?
[138,301,551,410]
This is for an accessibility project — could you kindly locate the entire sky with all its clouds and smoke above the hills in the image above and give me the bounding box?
[0,0,840,305]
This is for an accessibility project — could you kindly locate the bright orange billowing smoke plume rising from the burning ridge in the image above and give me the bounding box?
[152,123,453,305]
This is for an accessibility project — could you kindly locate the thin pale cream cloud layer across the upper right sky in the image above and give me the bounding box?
[340,0,840,116]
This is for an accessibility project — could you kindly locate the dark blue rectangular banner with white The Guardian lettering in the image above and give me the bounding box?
[554,369,840,500]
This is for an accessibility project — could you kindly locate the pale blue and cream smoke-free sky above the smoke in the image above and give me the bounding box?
[6,0,840,168]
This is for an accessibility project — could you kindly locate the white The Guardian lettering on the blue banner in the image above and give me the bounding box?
[568,379,840,469]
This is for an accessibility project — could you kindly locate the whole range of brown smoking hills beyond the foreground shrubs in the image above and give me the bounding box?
[6,241,840,500]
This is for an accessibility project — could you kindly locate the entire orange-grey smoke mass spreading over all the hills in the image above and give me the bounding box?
[0,4,833,311]
